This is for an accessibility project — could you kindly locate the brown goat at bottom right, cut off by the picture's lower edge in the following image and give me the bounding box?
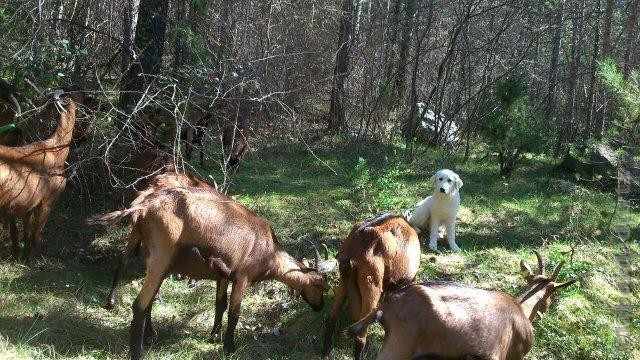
[345,251,576,360]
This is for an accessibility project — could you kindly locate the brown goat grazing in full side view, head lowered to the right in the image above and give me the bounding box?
[89,188,338,359]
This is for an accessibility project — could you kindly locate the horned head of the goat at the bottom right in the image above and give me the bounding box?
[520,250,577,312]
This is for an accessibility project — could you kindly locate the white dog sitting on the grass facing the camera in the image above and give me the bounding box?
[408,169,462,251]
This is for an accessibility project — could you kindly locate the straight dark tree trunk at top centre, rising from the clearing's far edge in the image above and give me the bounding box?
[328,0,353,131]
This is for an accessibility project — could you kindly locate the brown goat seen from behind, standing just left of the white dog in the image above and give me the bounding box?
[322,214,420,359]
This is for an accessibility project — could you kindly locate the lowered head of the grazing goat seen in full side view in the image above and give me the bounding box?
[300,241,337,311]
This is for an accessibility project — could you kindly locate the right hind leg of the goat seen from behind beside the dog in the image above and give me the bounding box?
[353,266,383,360]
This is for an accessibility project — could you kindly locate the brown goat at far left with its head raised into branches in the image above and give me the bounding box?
[0,93,76,265]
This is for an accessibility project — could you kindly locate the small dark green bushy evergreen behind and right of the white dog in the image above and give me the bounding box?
[483,77,550,176]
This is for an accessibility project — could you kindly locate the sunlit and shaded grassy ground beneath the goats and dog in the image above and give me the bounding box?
[0,136,640,359]
